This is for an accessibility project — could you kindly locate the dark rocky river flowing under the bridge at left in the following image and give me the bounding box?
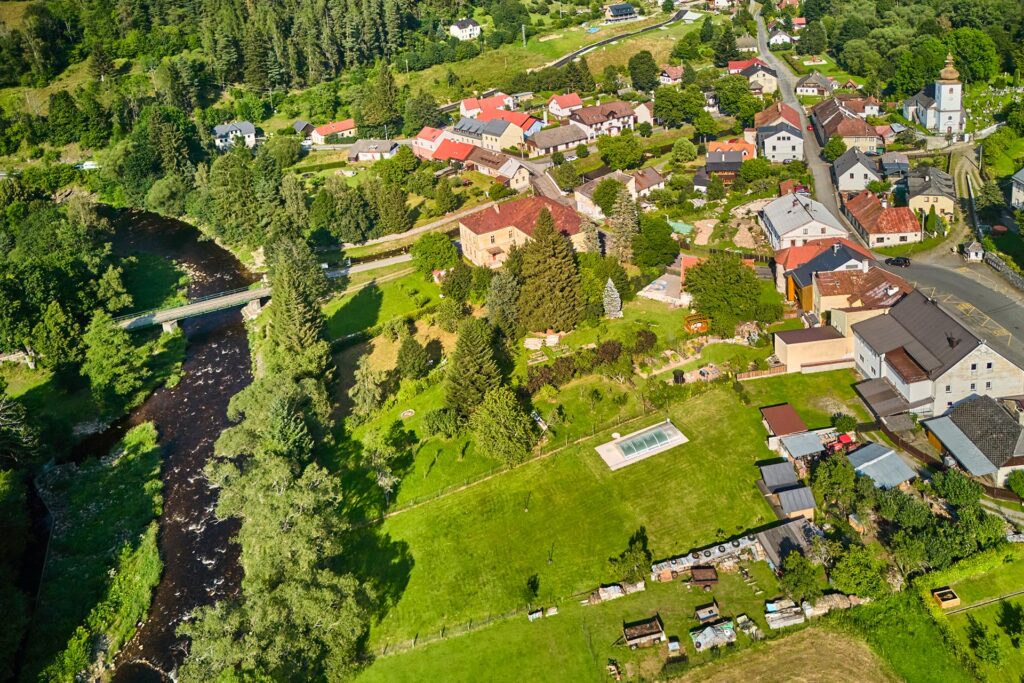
[94,212,255,683]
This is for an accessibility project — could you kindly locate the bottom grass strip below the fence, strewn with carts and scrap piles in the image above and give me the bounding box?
[358,562,777,683]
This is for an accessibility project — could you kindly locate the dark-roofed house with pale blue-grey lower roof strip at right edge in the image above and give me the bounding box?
[923,395,1024,486]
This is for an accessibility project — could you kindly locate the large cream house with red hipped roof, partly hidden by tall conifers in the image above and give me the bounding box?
[459,197,584,268]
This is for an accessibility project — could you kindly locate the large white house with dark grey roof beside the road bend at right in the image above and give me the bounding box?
[852,290,1024,418]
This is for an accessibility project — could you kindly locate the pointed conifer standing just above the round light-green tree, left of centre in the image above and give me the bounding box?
[444,317,501,417]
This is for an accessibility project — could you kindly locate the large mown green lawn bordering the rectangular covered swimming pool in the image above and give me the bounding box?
[365,388,773,646]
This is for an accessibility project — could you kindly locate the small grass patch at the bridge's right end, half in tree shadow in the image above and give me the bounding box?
[324,272,440,339]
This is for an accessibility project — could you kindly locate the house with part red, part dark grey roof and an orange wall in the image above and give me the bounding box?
[774,239,874,310]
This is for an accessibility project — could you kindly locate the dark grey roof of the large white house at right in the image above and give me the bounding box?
[853,290,981,380]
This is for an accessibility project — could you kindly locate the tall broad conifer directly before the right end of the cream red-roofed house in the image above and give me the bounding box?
[519,209,580,332]
